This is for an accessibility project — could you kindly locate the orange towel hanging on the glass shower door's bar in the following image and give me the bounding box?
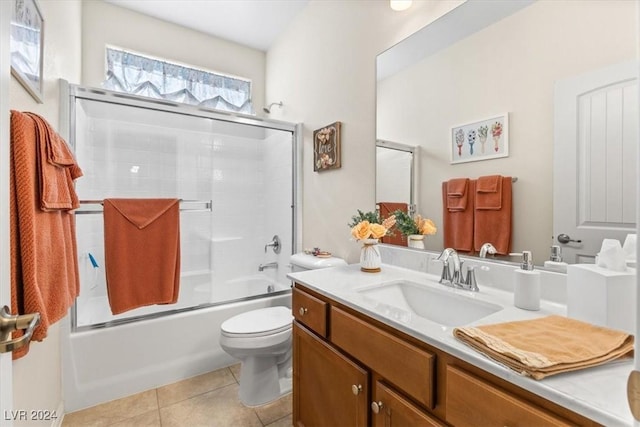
[104,199,180,314]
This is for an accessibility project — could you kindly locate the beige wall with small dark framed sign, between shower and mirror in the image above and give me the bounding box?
[267,0,460,262]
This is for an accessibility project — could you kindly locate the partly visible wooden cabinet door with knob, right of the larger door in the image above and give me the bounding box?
[371,381,446,427]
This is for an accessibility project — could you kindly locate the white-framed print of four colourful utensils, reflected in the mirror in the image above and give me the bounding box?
[449,113,509,164]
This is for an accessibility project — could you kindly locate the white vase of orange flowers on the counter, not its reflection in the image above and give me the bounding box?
[349,210,396,273]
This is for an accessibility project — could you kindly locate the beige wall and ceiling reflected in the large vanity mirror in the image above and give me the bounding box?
[376,0,637,265]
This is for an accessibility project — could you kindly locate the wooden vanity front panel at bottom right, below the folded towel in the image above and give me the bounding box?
[446,365,572,427]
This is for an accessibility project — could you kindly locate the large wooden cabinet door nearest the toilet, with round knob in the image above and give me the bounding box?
[293,322,369,427]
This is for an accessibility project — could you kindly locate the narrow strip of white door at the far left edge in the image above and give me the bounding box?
[0,1,13,426]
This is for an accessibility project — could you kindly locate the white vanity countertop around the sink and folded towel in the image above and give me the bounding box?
[288,264,633,426]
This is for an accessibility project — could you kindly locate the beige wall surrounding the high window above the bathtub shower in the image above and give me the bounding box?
[82,1,266,115]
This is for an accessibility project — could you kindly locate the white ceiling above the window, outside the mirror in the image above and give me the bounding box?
[105,0,308,51]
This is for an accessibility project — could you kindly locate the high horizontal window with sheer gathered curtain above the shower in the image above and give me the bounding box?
[102,47,253,114]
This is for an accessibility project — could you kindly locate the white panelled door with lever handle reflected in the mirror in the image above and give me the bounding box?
[553,61,638,263]
